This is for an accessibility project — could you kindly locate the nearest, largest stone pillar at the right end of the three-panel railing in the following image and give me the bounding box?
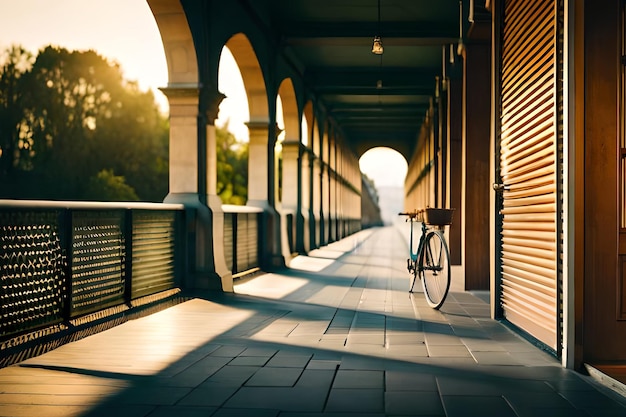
[162,84,232,291]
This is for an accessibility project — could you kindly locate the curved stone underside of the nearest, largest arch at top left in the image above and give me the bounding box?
[148,0,199,85]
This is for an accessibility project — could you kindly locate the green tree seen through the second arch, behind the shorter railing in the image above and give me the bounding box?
[216,124,248,205]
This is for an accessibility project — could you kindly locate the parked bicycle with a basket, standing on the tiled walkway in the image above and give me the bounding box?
[398,208,454,310]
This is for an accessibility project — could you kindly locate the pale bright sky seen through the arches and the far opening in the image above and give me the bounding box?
[0,0,406,187]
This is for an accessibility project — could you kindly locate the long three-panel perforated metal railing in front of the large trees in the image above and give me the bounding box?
[0,200,185,340]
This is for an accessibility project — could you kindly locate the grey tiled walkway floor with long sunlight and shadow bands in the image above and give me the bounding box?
[0,228,626,417]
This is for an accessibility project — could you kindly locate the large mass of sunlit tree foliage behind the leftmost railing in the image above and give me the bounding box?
[0,46,168,201]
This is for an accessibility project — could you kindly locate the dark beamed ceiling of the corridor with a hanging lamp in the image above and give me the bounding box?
[254,0,467,159]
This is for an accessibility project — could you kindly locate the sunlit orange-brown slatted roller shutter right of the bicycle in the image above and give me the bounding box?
[500,0,560,350]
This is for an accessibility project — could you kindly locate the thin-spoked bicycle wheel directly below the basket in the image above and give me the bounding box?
[419,230,450,309]
